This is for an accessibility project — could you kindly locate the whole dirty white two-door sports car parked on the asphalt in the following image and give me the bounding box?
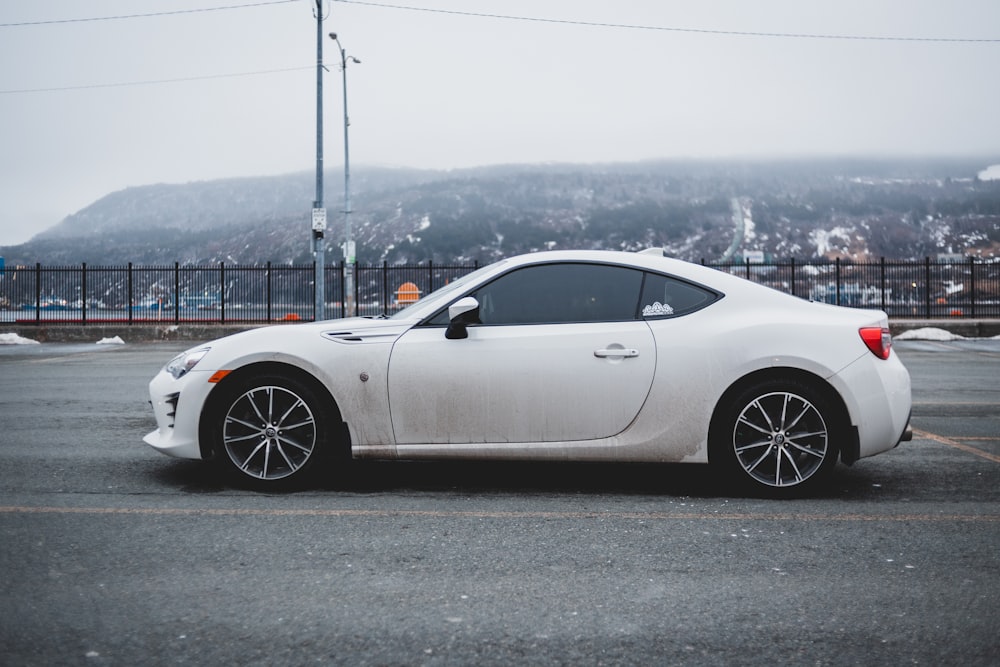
[145,250,910,495]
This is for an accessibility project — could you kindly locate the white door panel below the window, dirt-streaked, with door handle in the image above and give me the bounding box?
[389,321,656,445]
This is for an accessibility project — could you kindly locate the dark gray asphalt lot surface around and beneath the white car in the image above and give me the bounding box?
[0,340,1000,665]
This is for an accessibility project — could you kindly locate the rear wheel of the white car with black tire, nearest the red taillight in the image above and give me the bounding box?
[709,380,842,497]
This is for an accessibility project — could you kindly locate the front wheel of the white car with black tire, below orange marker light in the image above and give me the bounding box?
[210,375,331,490]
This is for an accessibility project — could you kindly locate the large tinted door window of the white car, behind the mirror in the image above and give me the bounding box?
[473,264,642,325]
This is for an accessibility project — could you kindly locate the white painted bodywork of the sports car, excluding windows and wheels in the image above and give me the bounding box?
[144,251,910,486]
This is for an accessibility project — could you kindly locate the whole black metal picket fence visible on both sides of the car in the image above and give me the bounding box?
[0,258,1000,324]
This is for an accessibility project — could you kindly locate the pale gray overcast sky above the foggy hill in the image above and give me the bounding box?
[0,0,1000,245]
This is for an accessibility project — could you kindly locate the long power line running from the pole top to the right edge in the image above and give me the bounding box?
[335,0,1000,44]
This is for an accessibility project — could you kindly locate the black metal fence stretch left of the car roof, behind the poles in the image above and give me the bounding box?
[0,262,478,324]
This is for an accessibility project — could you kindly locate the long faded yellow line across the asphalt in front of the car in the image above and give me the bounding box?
[0,506,1000,523]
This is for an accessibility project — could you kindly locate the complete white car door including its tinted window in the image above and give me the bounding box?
[388,263,656,444]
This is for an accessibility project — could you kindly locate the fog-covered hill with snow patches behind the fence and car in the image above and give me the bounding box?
[0,158,1000,265]
